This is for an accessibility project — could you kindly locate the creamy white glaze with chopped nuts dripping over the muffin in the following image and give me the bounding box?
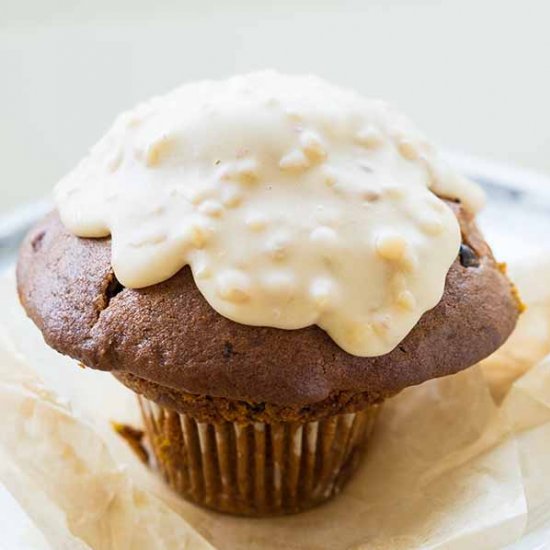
[55,71,482,356]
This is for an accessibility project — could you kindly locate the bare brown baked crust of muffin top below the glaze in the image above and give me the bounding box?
[17,202,520,412]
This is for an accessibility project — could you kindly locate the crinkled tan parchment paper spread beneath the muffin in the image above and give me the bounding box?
[0,261,550,550]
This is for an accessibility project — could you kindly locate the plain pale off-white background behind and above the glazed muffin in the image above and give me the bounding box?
[0,0,550,213]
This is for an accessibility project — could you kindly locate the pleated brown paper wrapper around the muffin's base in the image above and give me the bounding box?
[138,395,378,516]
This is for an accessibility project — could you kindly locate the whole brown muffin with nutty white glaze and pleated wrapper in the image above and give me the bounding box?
[17,71,521,516]
